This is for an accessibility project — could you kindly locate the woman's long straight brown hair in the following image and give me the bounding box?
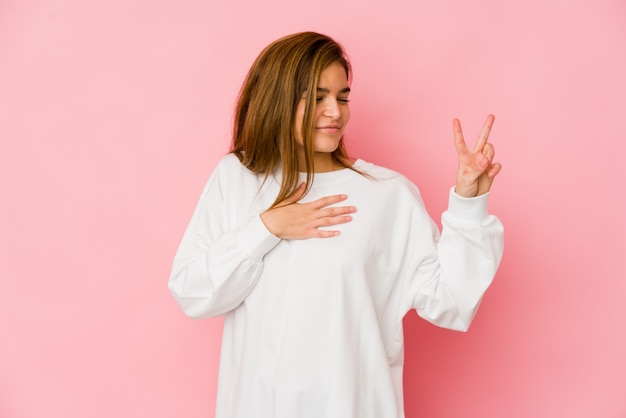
[231,32,352,207]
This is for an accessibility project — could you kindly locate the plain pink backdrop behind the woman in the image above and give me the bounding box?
[0,0,626,418]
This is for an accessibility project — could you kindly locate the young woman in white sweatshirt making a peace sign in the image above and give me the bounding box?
[169,32,503,418]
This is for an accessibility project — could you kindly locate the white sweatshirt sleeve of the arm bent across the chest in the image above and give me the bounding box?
[168,162,280,318]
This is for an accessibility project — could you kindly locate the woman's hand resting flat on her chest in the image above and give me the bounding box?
[261,183,356,239]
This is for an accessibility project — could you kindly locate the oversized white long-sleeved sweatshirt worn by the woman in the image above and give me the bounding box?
[169,154,503,418]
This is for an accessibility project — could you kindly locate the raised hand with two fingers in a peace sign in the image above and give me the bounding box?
[452,115,502,197]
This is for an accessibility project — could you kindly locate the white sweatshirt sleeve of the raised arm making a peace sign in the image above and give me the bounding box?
[404,189,504,331]
